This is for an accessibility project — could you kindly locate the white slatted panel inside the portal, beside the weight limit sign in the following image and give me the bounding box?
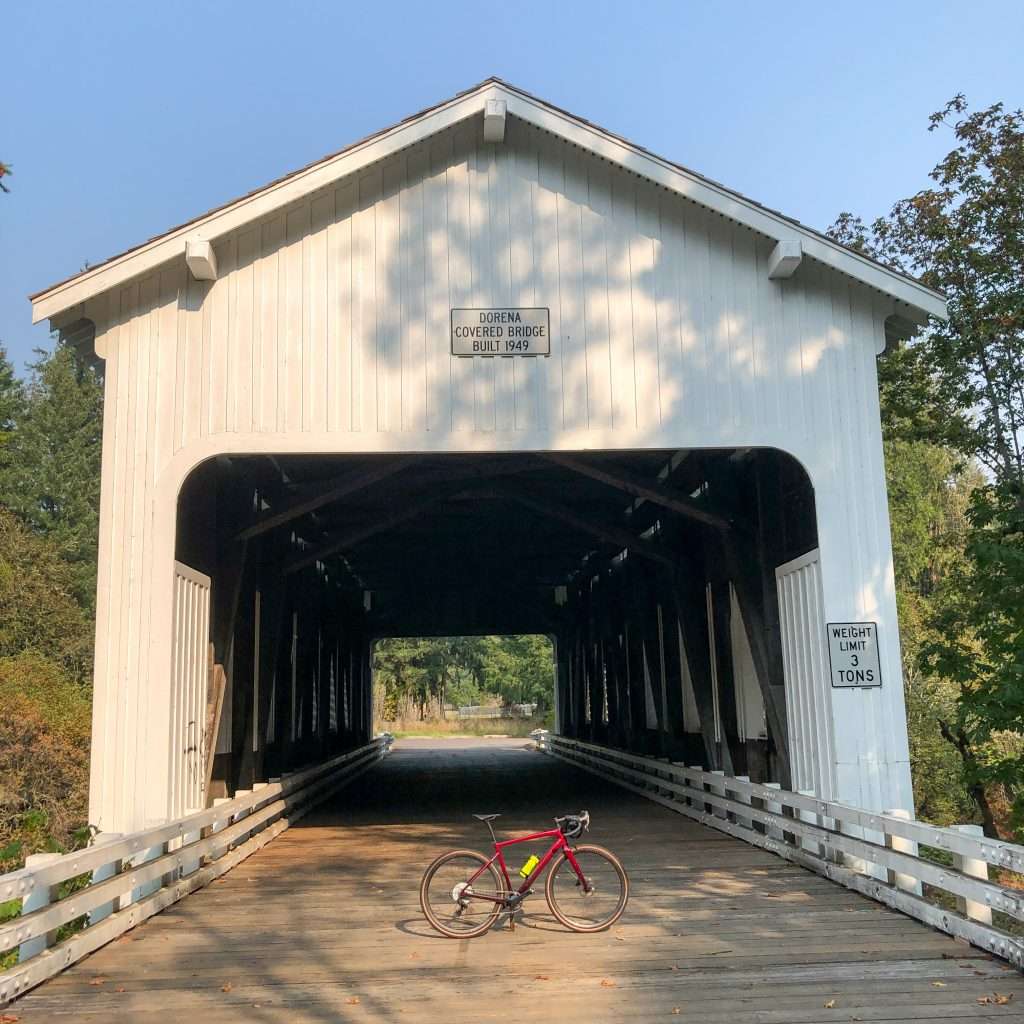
[775,550,836,800]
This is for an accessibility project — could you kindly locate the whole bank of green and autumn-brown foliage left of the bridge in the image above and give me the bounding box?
[0,346,100,871]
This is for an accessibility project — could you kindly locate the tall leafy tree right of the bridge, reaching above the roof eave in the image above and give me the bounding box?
[831,95,1024,835]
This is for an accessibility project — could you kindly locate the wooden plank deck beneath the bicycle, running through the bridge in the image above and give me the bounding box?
[14,740,1024,1024]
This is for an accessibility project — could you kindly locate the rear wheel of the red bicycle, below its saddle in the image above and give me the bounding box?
[420,850,505,939]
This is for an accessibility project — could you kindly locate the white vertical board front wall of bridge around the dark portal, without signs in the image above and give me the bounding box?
[86,118,910,830]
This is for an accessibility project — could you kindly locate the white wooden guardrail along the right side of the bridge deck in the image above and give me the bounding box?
[535,731,1024,968]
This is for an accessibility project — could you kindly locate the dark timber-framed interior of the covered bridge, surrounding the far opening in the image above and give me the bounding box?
[172,449,815,799]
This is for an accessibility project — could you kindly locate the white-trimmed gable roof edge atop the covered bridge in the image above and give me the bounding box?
[30,78,946,323]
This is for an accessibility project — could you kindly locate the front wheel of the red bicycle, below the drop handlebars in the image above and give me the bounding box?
[544,846,630,932]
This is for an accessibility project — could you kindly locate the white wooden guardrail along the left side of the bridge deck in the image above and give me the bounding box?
[0,733,392,1007]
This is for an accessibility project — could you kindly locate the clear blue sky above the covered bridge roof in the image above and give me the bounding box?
[0,0,1024,372]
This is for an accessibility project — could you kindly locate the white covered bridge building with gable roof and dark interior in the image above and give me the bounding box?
[33,80,944,831]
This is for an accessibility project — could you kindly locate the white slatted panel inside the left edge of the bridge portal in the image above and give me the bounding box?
[168,562,210,817]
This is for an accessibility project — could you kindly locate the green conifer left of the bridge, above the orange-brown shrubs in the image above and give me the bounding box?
[0,345,102,611]
